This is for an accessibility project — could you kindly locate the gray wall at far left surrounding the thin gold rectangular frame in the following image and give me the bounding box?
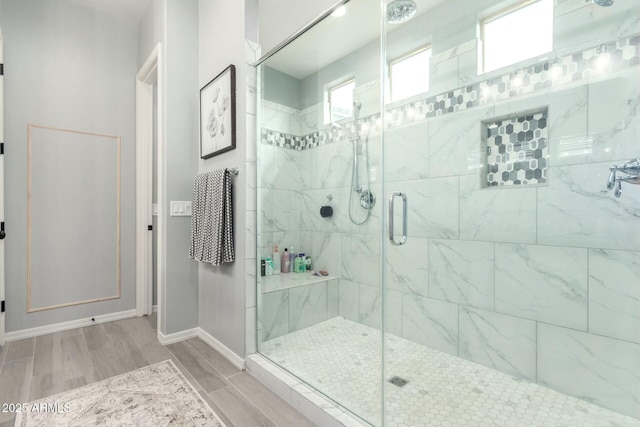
[0,0,137,332]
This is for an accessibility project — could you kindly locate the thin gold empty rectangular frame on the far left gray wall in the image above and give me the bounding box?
[27,124,121,313]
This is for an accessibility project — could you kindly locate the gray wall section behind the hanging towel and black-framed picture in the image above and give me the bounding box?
[198,0,255,356]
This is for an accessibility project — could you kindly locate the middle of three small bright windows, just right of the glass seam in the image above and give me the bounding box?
[389,46,431,102]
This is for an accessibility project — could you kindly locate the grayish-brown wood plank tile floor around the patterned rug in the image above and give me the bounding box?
[0,315,314,427]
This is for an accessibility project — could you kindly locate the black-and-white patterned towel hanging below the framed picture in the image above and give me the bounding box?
[189,169,236,266]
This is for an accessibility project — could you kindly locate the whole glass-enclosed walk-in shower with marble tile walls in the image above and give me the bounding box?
[257,0,640,426]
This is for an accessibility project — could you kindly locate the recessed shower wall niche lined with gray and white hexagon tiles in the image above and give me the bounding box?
[482,108,549,187]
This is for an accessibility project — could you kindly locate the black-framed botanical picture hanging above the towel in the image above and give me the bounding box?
[200,64,236,159]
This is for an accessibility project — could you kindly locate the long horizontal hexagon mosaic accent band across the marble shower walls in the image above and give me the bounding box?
[260,35,640,150]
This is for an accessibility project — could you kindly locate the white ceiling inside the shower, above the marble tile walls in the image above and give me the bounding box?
[267,0,446,79]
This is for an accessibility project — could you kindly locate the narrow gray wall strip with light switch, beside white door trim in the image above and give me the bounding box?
[159,0,200,334]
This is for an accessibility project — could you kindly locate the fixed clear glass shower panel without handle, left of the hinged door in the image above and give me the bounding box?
[256,0,385,425]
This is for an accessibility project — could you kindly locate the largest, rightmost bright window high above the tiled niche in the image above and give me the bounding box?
[478,0,554,74]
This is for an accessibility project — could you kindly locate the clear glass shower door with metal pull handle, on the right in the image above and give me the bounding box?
[381,0,640,426]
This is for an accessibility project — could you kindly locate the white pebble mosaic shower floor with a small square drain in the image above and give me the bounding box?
[261,317,640,427]
